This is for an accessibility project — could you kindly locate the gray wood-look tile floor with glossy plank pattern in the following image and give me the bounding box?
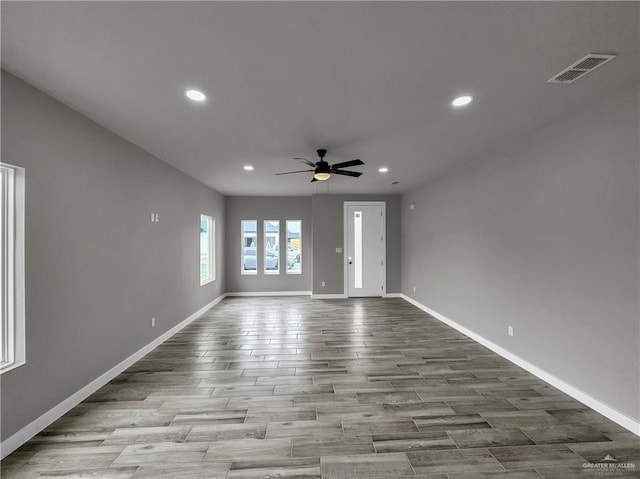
[1,297,640,479]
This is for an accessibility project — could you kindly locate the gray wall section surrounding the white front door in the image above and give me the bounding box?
[312,195,401,294]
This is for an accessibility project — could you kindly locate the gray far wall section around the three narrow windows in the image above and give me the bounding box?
[225,196,313,293]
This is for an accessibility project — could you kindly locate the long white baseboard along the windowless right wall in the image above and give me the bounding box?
[401,294,640,436]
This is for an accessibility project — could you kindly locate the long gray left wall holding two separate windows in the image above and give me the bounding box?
[1,72,225,440]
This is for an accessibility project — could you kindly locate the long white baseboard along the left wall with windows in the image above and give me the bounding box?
[0,294,225,459]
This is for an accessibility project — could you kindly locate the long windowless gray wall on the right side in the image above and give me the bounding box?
[402,89,640,421]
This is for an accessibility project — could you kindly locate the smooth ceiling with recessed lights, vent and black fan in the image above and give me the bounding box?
[2,1,640,195]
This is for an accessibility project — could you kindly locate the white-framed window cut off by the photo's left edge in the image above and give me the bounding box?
[0,163,26,374]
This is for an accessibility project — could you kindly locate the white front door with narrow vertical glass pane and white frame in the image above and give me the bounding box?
[345,202,386,297]
